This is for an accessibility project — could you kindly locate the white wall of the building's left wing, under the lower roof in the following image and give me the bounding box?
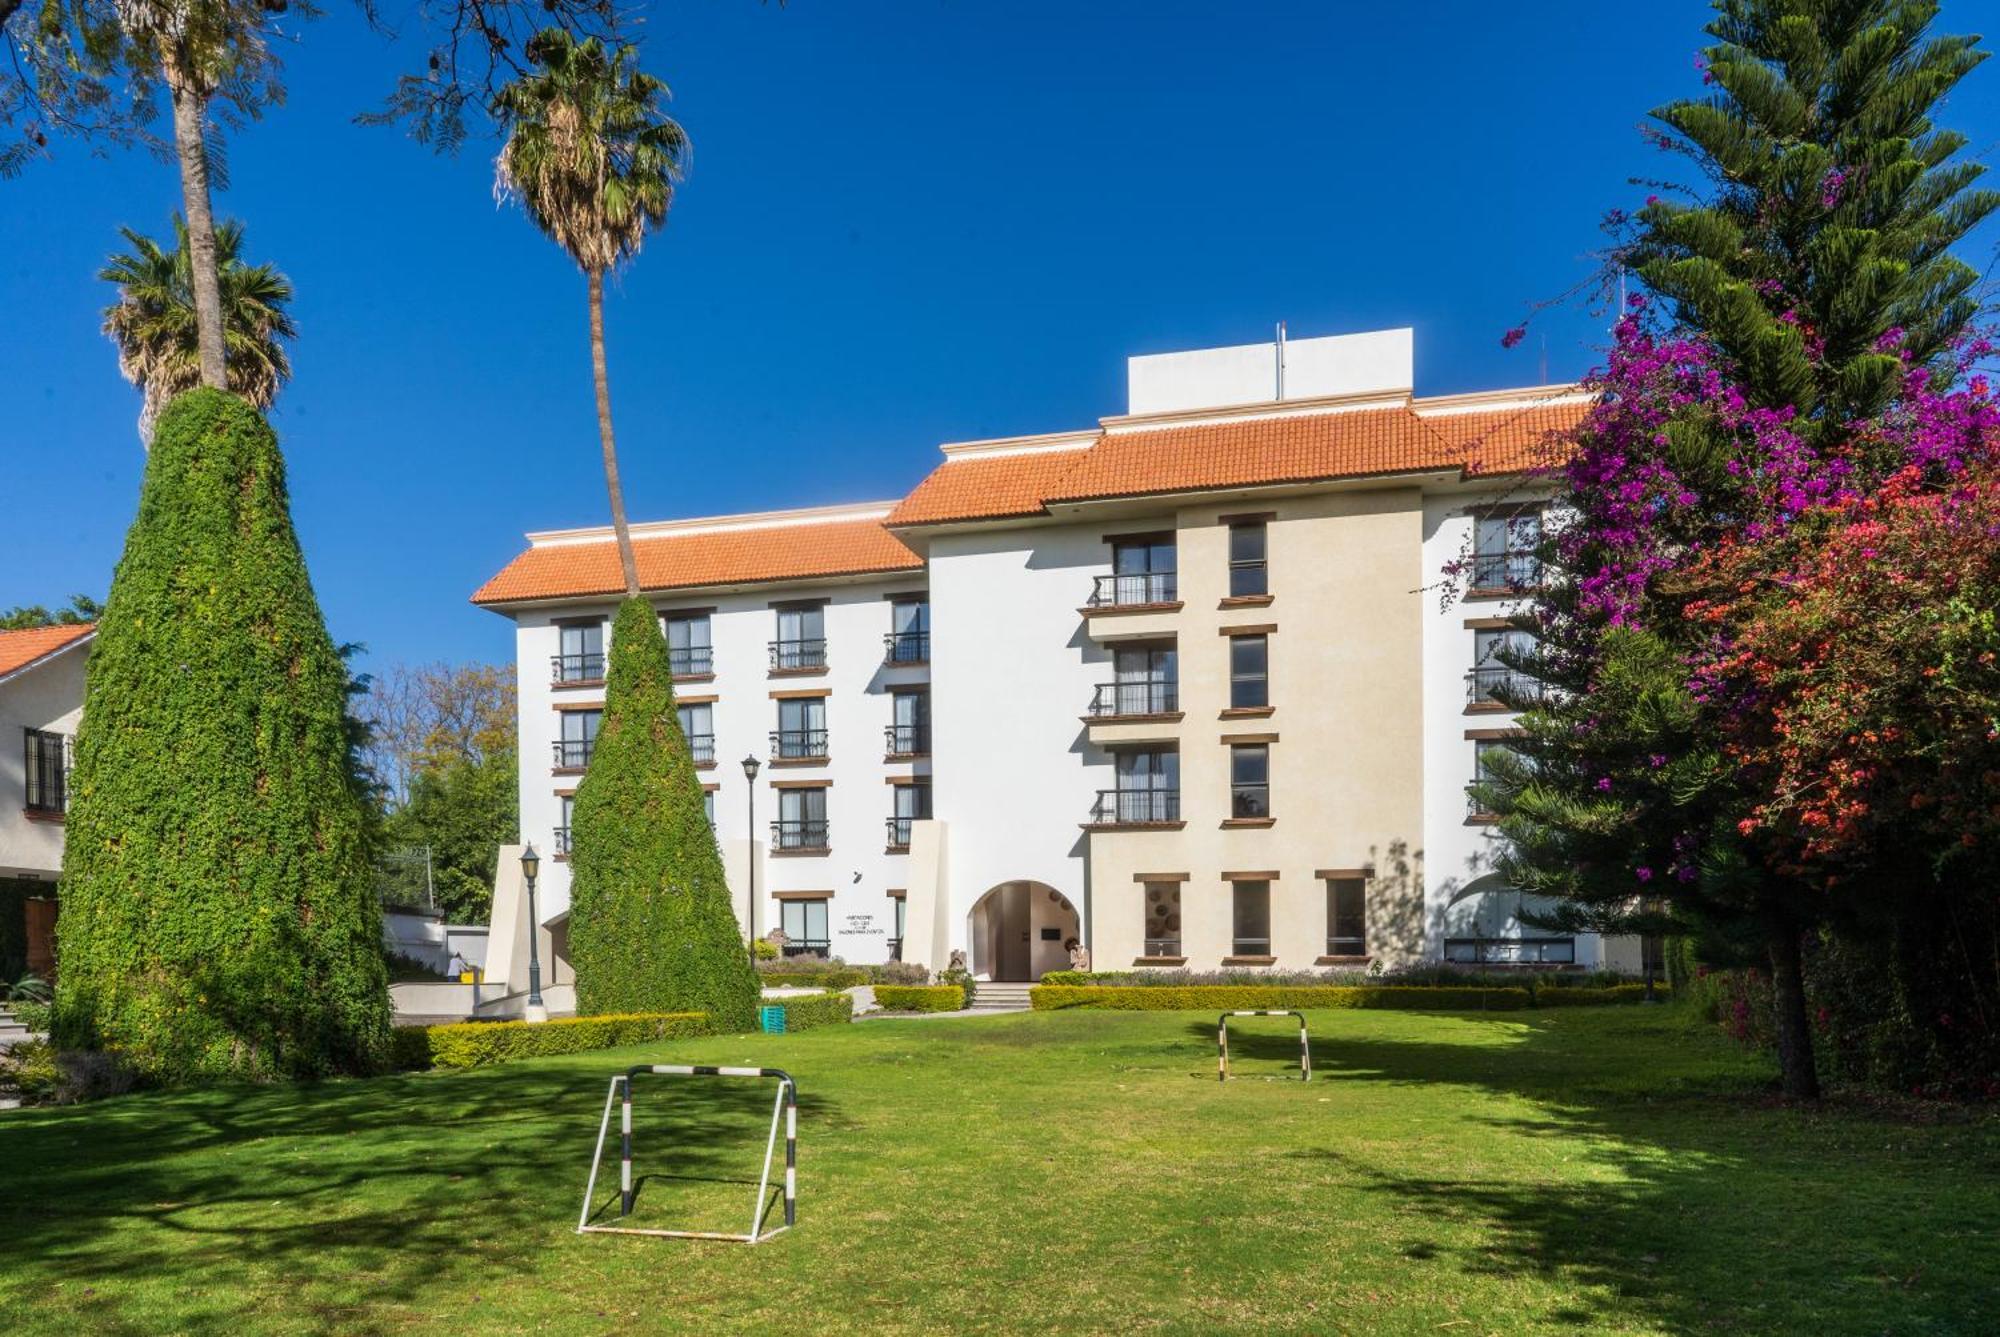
[516,572,930,963]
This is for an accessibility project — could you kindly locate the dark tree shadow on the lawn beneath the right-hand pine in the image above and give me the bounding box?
[1188,1015,2000,1333]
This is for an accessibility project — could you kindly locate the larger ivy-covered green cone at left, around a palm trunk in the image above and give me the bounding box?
[54,390,390,1081]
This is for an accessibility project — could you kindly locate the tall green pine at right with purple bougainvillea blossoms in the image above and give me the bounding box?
[1486,0,2000,1099]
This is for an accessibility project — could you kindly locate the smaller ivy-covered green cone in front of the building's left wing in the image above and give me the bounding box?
[570,598,758,1031]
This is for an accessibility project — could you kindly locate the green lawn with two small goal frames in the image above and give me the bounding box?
[0,1007,2000,1337]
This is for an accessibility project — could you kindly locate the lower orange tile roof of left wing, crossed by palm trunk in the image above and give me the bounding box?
[472,518,924,604]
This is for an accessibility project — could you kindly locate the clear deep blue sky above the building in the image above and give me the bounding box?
[0,0,2000,664]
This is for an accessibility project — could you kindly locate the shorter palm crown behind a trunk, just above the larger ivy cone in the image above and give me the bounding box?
[98,214,298,444]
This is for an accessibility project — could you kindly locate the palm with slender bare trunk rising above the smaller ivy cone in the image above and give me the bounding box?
[494,28,688,594]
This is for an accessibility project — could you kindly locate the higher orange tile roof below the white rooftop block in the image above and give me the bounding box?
[888,388,1590,526]
